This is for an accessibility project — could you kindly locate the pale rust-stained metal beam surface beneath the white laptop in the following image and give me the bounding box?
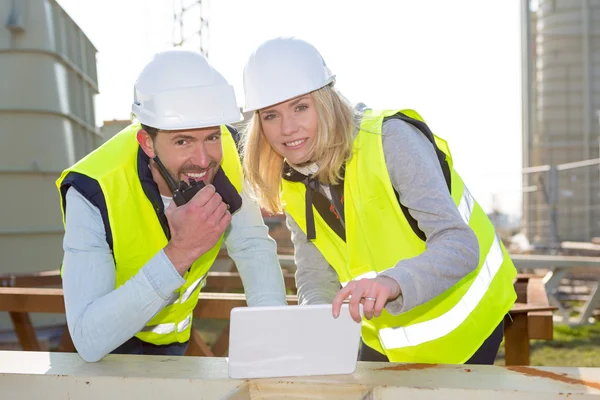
[0,351,600,400]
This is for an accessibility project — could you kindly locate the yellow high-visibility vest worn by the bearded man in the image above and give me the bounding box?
[56,124,243,345]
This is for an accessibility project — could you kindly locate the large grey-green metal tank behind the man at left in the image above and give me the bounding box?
[0,0,102,334]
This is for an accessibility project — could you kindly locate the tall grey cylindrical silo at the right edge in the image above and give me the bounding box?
[523,0,600,244]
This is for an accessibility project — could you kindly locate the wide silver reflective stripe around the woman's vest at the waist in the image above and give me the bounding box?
[379,236,504,350]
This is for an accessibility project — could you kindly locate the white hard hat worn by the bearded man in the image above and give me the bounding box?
[132,49,242,130]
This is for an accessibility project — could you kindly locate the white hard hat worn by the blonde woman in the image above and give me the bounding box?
[244,37,335,111]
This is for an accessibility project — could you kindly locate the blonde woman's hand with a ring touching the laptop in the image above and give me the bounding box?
[332,276,401,322]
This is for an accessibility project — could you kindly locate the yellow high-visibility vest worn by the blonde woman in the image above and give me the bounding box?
[281,110,516,364]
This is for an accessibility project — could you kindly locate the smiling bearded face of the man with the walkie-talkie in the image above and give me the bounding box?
[138,126,223,194]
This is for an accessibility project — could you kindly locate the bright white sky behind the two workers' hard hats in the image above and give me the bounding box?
[58,0,521,214]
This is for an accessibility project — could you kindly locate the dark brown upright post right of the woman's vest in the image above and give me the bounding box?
[504,312,529,365]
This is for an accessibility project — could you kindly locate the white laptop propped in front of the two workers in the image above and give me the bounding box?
[229,304,362,379]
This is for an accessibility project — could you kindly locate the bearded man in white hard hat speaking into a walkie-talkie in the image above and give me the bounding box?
[57,50,286,361]
